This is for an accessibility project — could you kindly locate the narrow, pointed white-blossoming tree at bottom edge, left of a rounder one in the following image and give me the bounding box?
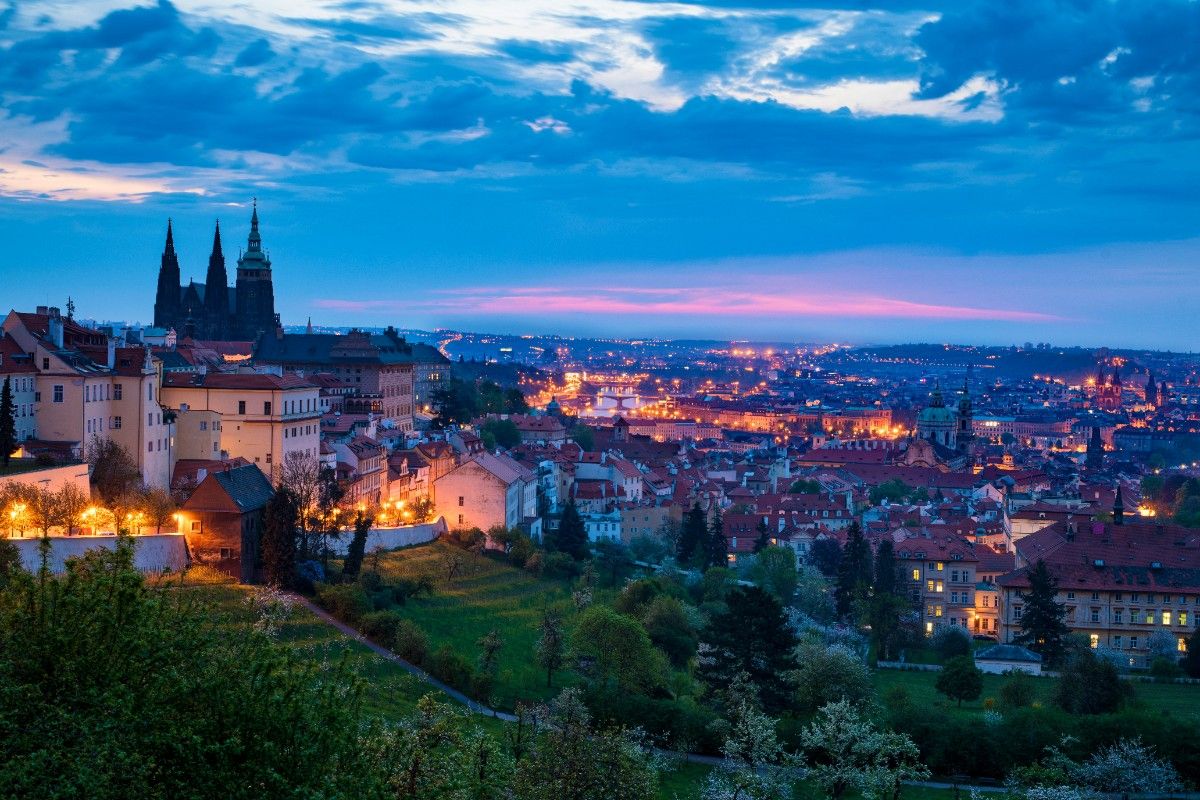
[702,674,799,800]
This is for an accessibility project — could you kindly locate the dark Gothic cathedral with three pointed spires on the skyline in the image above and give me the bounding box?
[154,201,280,342]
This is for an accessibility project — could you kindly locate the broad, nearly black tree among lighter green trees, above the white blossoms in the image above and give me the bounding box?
[698,587,797,710]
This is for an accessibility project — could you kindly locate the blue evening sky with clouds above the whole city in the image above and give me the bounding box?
[0,0,1200,350]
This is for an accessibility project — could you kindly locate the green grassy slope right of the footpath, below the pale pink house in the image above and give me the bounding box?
[365,542,590,709]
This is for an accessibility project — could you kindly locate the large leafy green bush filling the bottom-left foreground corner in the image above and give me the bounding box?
[0,541,384,800]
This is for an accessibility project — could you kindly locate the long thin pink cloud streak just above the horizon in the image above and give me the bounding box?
[316,284,1062,321]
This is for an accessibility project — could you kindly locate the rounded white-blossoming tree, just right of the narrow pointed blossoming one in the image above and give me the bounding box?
[800,700,929,800]
